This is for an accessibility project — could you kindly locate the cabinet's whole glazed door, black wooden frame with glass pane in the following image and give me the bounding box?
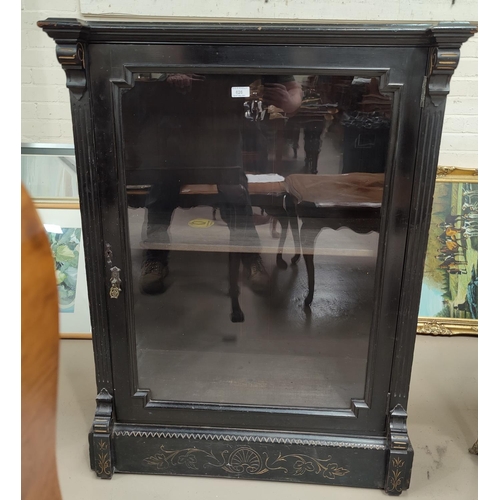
[90,44,427,435]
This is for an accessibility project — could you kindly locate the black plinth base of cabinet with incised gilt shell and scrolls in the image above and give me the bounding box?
[86,423,413,493]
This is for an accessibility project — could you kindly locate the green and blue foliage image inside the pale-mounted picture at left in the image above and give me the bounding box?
[47,227,82,313]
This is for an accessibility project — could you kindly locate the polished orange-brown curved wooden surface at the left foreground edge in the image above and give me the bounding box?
[21,187,61,500]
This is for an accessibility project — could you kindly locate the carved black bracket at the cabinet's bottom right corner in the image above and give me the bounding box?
[385,404,413,495]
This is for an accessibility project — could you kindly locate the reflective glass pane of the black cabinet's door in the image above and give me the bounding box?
[121,73,391,408]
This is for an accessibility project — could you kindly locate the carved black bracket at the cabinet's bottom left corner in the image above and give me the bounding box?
[89,389,113,479]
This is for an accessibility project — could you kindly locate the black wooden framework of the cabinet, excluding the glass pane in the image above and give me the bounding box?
[38,19,476,494]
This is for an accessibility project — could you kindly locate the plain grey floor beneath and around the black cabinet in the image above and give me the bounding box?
[57,336,478,500]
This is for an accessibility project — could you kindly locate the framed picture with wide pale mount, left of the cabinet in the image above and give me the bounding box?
[35,204,91,338]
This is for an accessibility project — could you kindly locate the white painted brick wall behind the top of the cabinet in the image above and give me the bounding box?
[21,0,478,167]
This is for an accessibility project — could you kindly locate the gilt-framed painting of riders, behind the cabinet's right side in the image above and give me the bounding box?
[417,167,479,335]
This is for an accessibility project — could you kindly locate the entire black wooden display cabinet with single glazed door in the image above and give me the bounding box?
[38,19,476,494]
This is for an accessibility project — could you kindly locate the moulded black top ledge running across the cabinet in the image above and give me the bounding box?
[38,18,477,45]
